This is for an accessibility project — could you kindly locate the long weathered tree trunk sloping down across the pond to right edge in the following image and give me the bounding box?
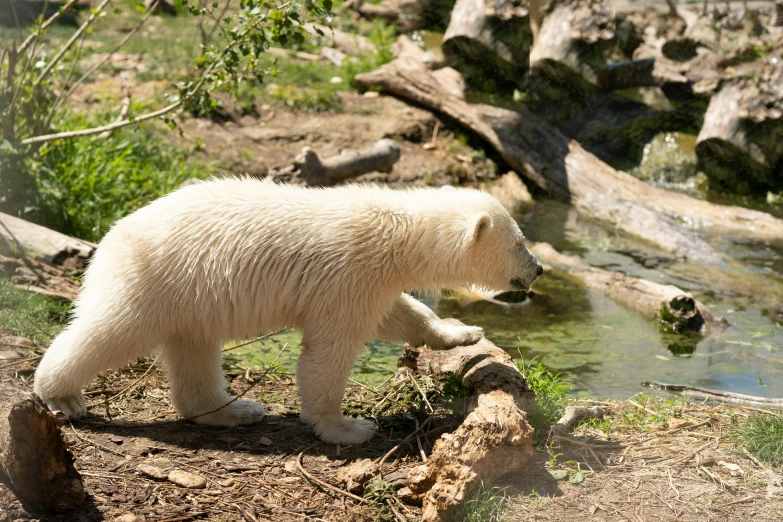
[355,45,783,248]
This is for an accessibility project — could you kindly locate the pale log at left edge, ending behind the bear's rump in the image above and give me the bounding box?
[0,212,95,270]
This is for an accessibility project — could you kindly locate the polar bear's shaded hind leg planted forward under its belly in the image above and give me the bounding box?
[161,337,264,427]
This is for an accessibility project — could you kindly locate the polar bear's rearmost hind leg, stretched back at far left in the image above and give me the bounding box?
[34,316,147,419]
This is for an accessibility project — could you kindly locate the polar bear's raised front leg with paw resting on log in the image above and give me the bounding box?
[377,294,484,350]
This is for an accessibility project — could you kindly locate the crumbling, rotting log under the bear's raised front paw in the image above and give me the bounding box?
[403,319,534,522]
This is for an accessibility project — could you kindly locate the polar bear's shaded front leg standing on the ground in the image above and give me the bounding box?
[296,339,375,444]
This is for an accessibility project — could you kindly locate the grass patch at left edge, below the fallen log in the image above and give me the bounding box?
[0,277,71,345]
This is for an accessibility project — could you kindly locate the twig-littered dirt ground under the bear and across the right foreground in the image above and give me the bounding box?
[0,336,783,522]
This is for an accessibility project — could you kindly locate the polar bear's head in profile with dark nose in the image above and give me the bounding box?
[461,194,544,291]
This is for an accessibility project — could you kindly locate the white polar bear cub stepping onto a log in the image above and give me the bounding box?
[35,178,542,444]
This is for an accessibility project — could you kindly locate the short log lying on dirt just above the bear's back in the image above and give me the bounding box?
[270,139,400,187]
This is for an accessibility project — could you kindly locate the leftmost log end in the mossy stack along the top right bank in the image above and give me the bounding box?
[442,0,532,81]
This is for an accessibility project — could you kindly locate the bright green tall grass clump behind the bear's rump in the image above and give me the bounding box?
[29,110,209,241]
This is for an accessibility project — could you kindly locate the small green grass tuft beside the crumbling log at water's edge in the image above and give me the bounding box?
[517,361,568,437]
